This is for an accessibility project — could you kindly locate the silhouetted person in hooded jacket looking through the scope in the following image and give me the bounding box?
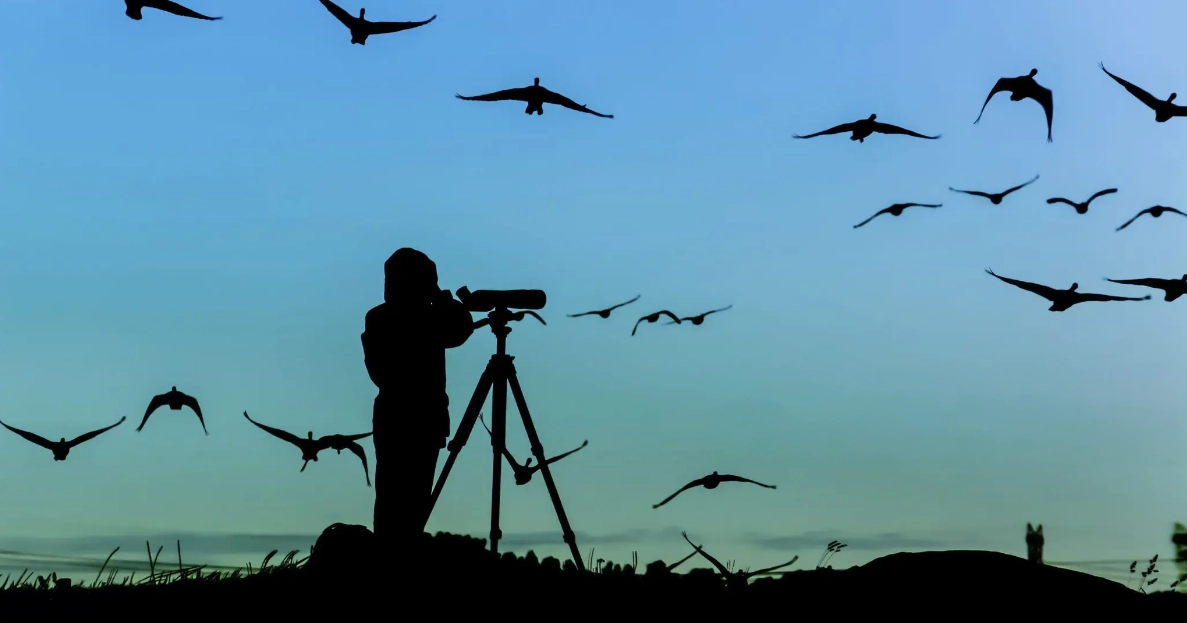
[362,248,474,545]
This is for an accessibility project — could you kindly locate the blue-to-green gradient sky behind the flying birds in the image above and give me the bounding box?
[0,0,1187,583]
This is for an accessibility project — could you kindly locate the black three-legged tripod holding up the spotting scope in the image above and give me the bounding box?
[425,307,585,571]
